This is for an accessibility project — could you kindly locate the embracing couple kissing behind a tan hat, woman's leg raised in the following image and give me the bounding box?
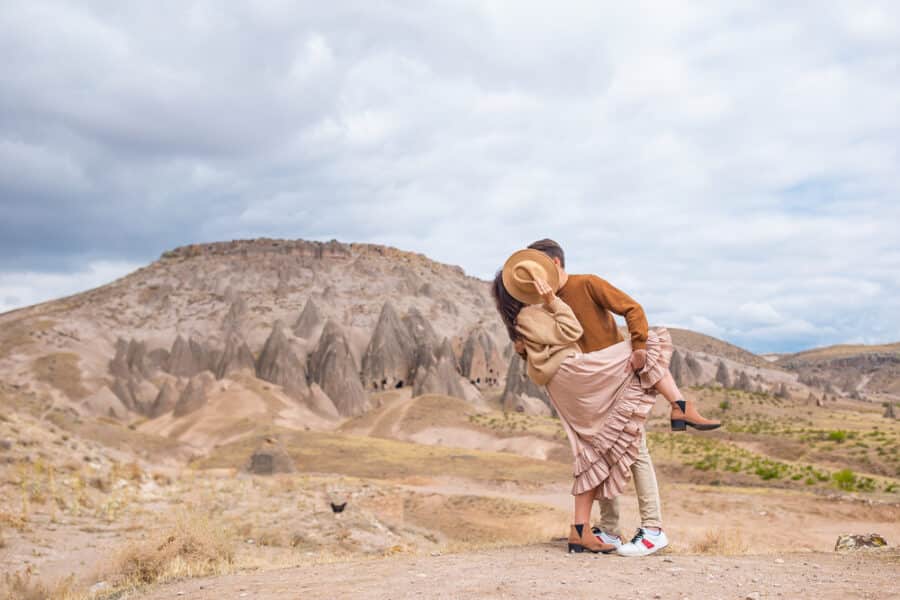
[493,240,720,556]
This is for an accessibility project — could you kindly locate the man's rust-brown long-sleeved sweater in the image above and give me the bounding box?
[556,275,648,353]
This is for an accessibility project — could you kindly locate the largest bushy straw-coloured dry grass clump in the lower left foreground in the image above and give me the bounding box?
[98,514,235,595]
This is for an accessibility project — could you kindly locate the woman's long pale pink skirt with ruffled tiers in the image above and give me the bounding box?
[547,327,672,498]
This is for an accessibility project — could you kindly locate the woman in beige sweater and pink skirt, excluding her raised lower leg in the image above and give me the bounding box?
[493,250,680,553]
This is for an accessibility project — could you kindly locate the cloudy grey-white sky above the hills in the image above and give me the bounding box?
[0,0,900,352]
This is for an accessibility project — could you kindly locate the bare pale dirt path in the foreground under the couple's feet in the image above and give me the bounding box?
[139,543,900,600]
